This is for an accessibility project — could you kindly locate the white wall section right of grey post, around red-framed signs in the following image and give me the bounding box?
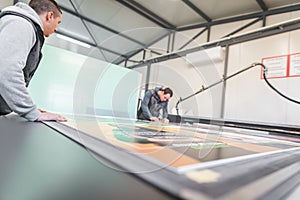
[225,28,300,124]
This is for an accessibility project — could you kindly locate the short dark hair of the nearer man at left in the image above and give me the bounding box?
[29,0,62,17]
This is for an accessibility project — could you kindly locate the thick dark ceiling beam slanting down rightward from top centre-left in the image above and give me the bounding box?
[116,0,176,29]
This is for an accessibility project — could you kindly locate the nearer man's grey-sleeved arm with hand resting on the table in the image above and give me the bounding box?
[0,16,66,121]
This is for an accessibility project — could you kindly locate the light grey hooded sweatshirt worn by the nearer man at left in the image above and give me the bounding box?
[0,3,43,121]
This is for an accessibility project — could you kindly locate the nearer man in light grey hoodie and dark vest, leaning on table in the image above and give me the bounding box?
[0,0,66,121]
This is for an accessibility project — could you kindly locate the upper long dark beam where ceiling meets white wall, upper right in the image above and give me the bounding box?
[176,4,300,31]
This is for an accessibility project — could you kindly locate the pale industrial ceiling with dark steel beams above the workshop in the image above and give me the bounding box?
[0,0,300,64]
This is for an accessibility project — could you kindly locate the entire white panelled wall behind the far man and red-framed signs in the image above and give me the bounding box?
[136,12,300,125]
